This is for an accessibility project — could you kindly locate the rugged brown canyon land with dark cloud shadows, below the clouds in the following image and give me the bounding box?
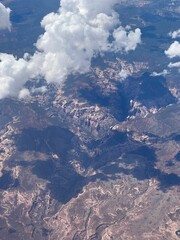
[0,60,180,240]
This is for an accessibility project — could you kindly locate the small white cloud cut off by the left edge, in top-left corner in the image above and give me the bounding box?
[0,3,11,30]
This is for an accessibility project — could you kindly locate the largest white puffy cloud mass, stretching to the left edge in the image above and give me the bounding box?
[0,0,141,98]
